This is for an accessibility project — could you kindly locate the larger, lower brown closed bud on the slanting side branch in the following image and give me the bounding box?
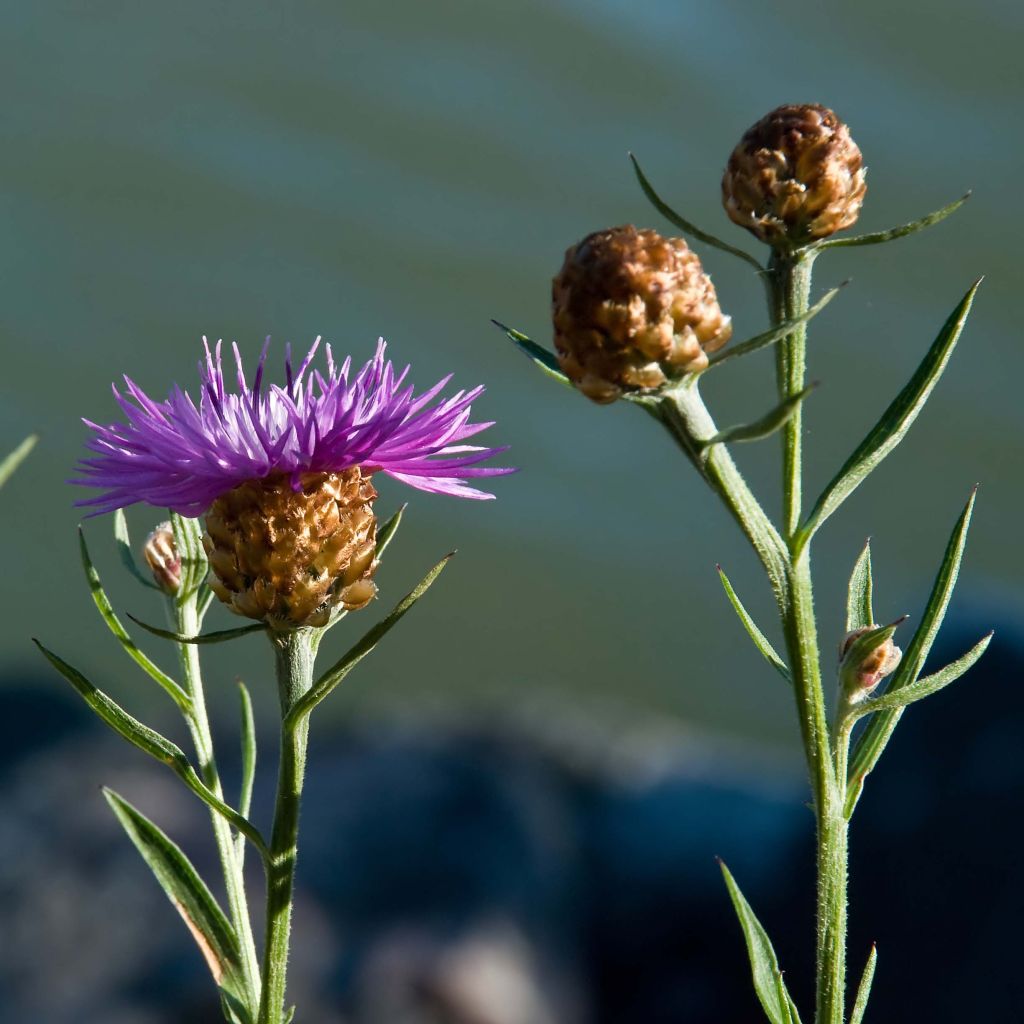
[552,224,732,403]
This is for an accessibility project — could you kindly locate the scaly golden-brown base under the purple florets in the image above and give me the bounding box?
[203,467,377,629]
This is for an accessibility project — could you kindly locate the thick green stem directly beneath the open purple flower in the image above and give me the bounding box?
[257,629,316,1024]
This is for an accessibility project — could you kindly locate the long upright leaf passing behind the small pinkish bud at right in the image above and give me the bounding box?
[846,488,977,817]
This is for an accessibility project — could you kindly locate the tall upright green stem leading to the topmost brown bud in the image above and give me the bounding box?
[768,251,849,1024]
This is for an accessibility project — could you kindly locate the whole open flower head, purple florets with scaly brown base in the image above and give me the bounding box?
[73,339,512,629]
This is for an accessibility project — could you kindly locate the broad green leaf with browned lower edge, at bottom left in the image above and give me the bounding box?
[103,787,246,1011]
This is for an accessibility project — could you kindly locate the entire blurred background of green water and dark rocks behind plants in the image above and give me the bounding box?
[0,0,1024,1024]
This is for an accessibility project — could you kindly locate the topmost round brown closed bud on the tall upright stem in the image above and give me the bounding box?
[722,103,867,247]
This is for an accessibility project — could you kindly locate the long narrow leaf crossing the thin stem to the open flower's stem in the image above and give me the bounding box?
[38,638,269,861]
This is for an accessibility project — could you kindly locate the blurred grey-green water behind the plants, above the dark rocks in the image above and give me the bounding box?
[0,0,1024,743]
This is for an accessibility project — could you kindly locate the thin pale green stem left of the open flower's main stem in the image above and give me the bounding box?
[174,592,260,1005]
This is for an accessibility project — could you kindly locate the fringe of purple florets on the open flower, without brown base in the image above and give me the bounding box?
[72,338,514,516]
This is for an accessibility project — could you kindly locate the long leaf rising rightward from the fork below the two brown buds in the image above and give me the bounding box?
[797,279,981,553]
